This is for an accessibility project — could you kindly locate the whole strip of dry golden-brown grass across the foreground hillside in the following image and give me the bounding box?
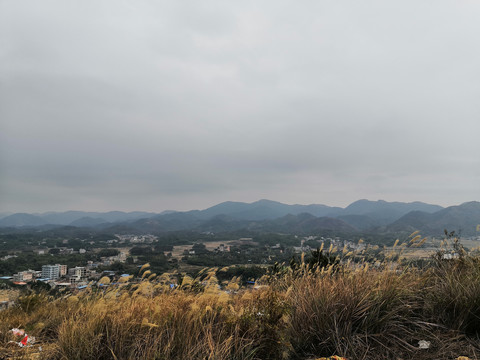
[0,238,480,360]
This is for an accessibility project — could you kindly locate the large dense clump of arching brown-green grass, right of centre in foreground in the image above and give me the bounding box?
[288,270,426,358]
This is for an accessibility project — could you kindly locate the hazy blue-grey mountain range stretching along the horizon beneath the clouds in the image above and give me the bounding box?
[0,199,480,235]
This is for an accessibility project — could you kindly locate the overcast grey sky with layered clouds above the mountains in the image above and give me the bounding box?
[0,0,480,212]
